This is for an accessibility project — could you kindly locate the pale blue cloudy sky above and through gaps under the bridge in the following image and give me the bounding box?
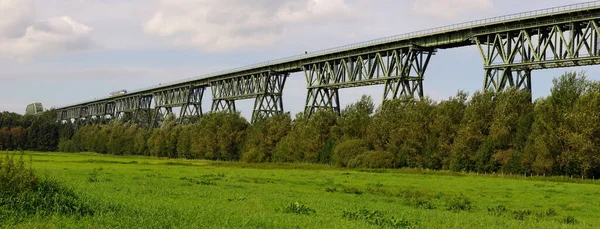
[0,0,600,121]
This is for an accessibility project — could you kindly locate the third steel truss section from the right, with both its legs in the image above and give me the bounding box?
[210,71,289,122]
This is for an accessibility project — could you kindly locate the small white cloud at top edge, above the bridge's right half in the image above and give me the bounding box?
[412,0,494,19]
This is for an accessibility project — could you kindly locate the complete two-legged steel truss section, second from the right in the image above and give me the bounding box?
[303,46,435,115]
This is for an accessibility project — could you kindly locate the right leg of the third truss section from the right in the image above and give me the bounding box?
[252,73,290,123]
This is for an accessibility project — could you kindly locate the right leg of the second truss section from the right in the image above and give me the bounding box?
[383,46,435,101]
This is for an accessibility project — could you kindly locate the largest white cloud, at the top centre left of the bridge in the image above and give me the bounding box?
[144,0,352,50]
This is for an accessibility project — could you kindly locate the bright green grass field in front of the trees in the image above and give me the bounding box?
[1,153,600,228]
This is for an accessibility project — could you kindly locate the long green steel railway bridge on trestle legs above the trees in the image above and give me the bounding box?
[57,1,600,127]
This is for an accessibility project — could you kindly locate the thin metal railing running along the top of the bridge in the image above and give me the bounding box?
[58,1,600,107]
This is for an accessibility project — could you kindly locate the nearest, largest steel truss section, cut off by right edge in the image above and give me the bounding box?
[474,20,600,92]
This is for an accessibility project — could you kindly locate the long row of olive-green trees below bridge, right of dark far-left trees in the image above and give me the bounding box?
[1,72,600,178]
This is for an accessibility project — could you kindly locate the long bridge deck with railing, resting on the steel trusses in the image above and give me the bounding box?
[57,1,600,109]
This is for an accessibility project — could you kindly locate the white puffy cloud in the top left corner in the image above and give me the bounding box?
[0,0,94,60]
